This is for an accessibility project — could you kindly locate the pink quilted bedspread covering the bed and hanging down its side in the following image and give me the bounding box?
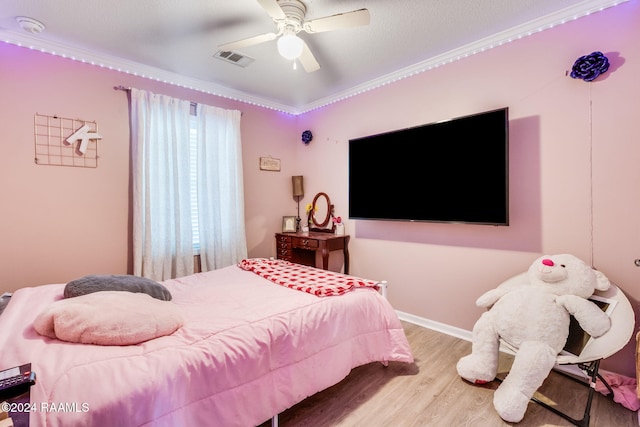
[0,266,413,427]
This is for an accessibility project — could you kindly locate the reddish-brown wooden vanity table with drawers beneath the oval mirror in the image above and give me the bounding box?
[276,232,349,274]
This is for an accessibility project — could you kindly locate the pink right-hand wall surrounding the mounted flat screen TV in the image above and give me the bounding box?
[296,2,640,375]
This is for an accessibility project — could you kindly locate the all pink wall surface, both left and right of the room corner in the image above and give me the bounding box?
[0,1,640,375]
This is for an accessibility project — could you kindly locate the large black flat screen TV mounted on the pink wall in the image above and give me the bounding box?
[349,108,509,225]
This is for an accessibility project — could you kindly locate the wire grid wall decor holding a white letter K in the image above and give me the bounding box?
[33,113,102,168]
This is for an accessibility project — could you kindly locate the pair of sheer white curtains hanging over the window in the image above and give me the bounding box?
[131,89,246,280]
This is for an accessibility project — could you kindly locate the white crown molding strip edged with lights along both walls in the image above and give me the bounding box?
[0,0,630,115]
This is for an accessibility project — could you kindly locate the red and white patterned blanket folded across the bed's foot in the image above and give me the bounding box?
[238,258,378,297]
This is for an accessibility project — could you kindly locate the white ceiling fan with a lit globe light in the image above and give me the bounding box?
[218,0,370,73]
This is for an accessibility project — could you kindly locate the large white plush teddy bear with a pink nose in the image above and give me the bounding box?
[457,254,611,422]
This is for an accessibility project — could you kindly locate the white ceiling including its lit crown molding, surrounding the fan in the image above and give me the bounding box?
[0,0,624,114]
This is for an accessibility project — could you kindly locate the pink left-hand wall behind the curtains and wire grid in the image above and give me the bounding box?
[0,43,292,292]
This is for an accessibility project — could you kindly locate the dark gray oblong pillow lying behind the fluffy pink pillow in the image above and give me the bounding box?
[64,274,171,301]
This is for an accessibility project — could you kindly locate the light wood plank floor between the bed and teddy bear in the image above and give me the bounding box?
[260,322,638,427]
